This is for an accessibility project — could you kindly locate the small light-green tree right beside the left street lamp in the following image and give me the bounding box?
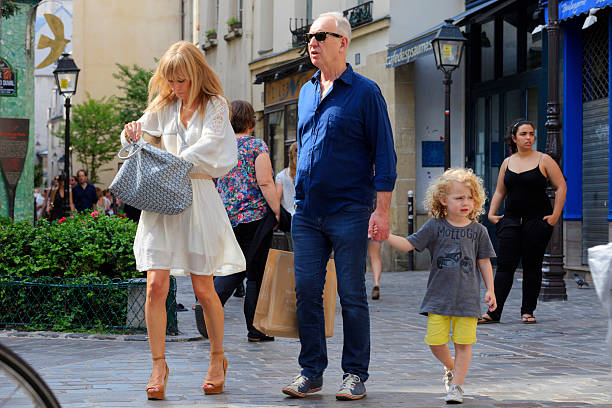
[55,94,121,183]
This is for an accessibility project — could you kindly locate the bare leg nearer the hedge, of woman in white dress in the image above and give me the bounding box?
[145,270,170,385]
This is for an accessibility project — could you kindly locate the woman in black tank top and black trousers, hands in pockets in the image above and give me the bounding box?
[478,119,567,324]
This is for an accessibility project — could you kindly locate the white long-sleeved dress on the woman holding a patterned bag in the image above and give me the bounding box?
[121,98,246,276]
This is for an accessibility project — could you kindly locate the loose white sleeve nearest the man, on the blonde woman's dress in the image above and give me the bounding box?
[182,98,238,178]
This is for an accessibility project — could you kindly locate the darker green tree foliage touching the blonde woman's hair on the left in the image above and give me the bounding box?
[113,64,153,124]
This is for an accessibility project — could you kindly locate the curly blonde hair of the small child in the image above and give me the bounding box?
[425,168,487,221]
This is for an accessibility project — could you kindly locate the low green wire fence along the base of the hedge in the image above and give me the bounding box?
[0,276,178,335]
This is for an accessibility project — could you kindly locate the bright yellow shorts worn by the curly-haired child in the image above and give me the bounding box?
[425,313,478,346]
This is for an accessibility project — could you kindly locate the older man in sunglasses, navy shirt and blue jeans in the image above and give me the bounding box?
[283,13,396,400]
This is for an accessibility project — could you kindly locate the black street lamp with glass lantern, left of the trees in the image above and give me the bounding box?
[53,53,80,214]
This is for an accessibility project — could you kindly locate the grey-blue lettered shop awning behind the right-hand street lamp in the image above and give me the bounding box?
[386,0,504,68]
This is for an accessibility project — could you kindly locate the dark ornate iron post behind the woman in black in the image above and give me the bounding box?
[539,0,567,301]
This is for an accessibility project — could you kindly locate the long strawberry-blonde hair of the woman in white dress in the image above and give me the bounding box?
[145,41,230,113]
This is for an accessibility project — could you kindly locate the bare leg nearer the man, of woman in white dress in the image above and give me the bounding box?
[191,274,225,383]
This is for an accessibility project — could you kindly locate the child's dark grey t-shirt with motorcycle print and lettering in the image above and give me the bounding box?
[407,218,495,317]
